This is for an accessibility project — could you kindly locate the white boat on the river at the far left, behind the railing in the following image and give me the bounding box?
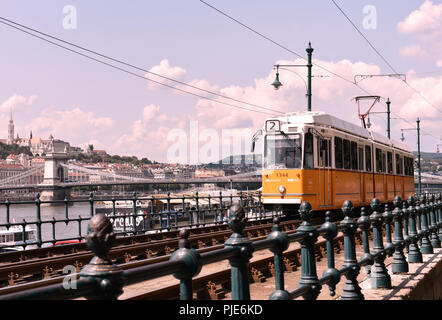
[0,226,36,252]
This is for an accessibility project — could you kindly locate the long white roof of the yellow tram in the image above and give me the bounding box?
[276,111,412,152]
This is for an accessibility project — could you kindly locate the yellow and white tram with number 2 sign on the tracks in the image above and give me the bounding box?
[253,112,414,214]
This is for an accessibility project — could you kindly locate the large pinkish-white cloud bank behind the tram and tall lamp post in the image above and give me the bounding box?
[113,53,442,161]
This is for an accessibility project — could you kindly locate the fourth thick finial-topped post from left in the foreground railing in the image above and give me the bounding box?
[339,200,364,300]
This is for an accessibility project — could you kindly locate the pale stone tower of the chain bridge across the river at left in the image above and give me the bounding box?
[40,151,71,201]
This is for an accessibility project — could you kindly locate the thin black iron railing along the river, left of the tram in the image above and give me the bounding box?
[0,192,268,252]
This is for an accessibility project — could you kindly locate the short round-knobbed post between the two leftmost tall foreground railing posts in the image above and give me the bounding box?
[170,229,202,300]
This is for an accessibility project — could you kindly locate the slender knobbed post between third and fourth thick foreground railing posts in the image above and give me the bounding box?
[321,211,341,297]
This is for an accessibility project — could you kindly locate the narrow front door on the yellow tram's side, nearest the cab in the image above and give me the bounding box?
[318,137,333,207]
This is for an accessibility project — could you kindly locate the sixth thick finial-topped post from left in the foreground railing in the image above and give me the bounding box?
[391,196,408,273]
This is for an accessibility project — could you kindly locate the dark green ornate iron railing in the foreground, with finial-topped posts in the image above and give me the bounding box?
[0,194,442,300]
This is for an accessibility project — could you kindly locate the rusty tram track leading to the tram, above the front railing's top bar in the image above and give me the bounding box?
[0,218,334,288]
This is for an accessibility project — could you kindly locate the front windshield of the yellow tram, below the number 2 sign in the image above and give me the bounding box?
[264,134,302,169]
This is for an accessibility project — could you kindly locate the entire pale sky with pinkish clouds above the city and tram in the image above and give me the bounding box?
[0,0,442,161]
